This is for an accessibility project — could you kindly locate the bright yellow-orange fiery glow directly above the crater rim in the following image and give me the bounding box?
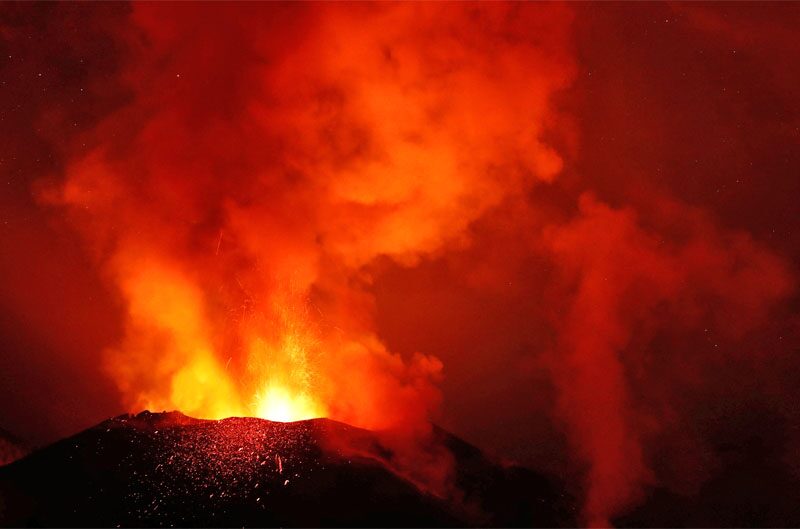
[104,256,326,422]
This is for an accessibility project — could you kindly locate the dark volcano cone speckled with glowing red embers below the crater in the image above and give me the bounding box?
[0,412,575,527]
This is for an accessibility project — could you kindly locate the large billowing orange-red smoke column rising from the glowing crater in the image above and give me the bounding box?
[42,0,571,456]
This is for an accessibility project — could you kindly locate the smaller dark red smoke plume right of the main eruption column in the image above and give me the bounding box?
[545,195,794,525]
